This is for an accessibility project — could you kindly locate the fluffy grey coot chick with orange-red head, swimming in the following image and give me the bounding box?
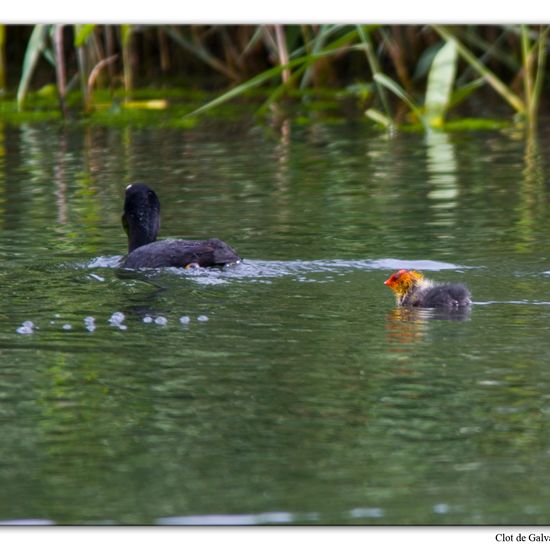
[384,269,472,308]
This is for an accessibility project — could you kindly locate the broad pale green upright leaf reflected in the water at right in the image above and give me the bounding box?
[425,38,457,127]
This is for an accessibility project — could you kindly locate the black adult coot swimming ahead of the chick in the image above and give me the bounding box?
[121,183,241,268]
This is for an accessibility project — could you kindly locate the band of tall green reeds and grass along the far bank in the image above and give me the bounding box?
[6,24,550,129]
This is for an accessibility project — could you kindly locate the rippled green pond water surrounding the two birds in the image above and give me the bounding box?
[0,119,550,525]
